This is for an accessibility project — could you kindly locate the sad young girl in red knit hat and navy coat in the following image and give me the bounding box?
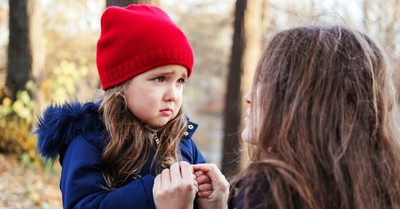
[36,5,205,209]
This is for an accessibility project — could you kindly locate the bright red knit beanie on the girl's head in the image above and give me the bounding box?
[96,5,194,90]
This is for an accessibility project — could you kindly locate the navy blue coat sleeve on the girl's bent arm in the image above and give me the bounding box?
[60,137,155,209]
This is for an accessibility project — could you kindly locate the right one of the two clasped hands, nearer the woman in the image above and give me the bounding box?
[193,164,229,209]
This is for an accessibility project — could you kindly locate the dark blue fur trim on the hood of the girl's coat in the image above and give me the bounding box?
[34,102,105,159]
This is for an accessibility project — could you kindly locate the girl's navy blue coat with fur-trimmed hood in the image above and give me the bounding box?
[35,102,205,209]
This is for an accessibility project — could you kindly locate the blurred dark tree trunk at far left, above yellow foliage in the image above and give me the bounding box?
[6,0,38,101]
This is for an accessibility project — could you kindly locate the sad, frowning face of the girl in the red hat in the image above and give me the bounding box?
[125,65,187,127]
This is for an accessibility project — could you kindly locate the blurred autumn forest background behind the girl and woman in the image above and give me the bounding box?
[0,0,400,208]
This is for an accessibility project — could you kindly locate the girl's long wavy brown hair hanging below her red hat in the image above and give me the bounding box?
[100,82,186,189]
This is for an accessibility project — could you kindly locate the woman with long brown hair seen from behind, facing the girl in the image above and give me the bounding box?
[239,25,400,209]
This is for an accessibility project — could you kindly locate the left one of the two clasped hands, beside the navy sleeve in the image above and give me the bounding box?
[153,161,198,209]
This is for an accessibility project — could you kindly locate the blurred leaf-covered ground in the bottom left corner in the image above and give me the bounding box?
[0,154,62,209]
